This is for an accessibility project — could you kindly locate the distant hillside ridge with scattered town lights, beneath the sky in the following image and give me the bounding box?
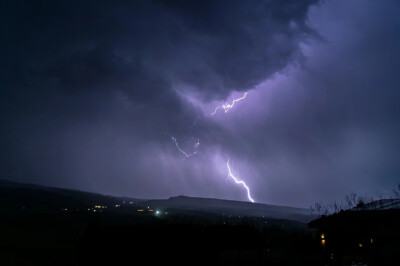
[0,180,317,223]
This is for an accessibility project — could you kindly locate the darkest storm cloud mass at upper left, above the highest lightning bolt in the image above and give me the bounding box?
[2,1,316,101]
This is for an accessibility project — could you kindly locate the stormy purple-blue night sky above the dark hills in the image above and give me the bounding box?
[0,0,400,207]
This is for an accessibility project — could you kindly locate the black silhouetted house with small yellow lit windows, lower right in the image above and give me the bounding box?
[309,208,400,265]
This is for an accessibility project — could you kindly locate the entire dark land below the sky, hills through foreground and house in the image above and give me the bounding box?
[0,181,400,265]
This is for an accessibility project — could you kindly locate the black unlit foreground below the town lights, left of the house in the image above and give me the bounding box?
[0,213,321,265]
